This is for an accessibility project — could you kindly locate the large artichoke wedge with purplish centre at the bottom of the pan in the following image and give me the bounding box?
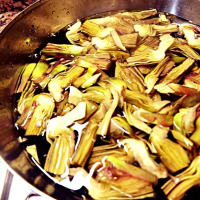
[96,156,157,197]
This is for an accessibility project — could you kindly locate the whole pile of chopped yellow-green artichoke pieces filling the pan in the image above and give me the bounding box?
[16,9,200,200]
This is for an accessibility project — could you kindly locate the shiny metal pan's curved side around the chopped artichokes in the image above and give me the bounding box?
[0,0,200,200]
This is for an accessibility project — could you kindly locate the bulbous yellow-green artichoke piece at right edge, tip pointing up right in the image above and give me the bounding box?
[173,104,199,136]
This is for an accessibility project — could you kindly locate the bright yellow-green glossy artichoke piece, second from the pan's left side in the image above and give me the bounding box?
[31,56,49,83]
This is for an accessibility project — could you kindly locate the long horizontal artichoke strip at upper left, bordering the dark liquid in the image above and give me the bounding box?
[41,43,85,56]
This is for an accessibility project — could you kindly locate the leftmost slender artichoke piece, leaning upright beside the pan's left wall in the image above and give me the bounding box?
[15,63,37,93]
